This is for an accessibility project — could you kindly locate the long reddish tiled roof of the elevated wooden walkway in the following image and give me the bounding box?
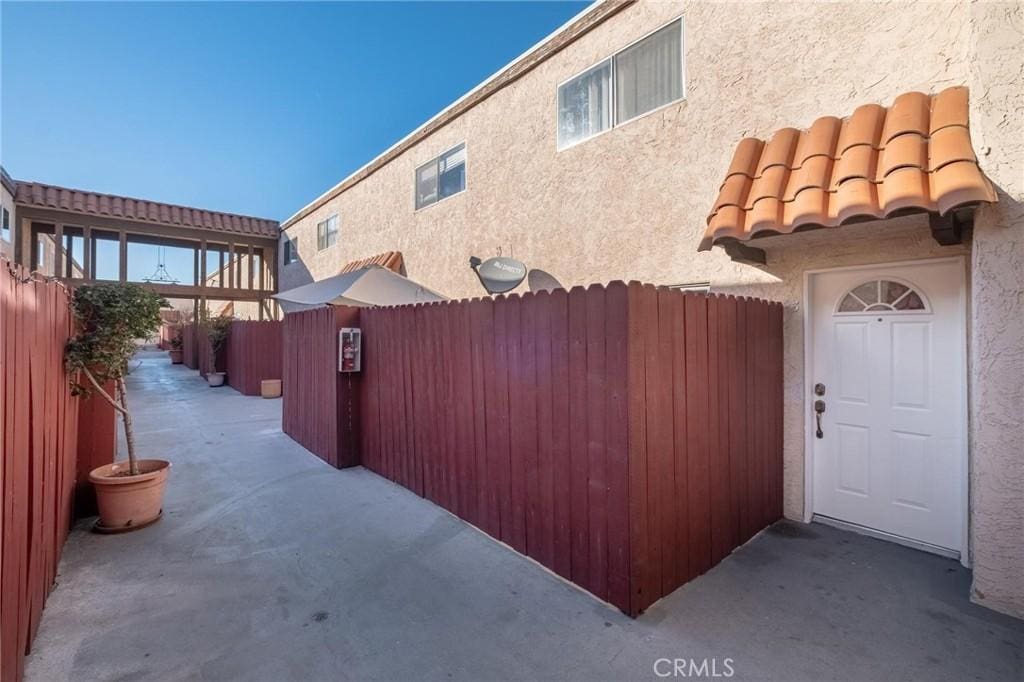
[14,180,280,238]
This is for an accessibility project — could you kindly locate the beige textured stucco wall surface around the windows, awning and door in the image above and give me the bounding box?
[281,2,1024,615]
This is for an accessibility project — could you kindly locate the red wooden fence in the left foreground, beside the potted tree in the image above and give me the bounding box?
[0,260,79,681]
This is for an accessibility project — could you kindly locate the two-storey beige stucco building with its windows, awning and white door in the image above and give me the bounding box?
[279,2,1024,615]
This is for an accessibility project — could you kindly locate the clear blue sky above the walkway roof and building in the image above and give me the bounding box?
[0,1,587,225]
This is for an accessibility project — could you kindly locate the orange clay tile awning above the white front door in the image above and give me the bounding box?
[698,87,996,251]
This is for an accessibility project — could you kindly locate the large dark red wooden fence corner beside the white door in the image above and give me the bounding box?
[356,283,782,615]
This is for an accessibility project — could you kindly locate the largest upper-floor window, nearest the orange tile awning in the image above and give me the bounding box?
[558,18,683,148]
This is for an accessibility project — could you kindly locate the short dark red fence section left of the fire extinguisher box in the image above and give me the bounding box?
[282,307,359,467]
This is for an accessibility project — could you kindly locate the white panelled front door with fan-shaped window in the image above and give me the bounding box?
[807,258,967,552]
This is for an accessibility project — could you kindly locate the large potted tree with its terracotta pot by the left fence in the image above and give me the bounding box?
[65,284,171,532]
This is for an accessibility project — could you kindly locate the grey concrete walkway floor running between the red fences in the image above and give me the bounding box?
[28,352,1024,682]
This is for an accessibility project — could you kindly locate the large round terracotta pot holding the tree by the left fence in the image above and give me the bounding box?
[89,460,171,532]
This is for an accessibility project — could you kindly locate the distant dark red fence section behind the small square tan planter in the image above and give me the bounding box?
[224,321,284,395]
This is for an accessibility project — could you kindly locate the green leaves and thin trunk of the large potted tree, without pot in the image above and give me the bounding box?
[65,283,168,474]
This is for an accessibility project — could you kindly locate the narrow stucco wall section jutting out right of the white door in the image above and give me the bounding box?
[969,3,1024,617]
